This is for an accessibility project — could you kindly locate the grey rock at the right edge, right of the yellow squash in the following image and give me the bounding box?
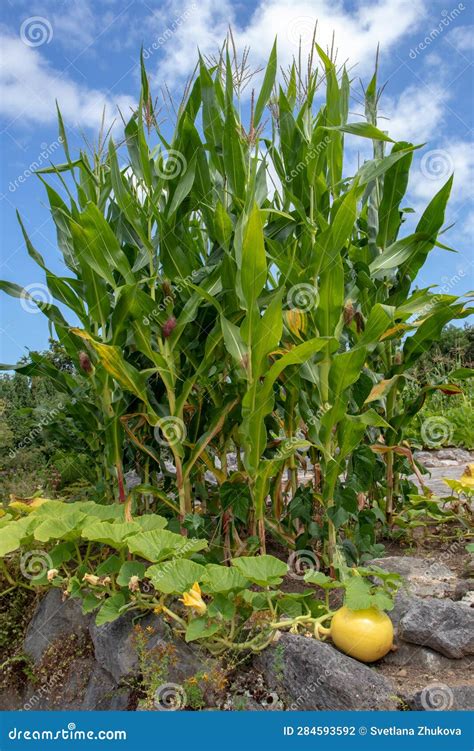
[398,599,474,659]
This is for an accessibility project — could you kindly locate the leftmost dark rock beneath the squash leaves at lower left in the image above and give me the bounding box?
[23,589,90,665]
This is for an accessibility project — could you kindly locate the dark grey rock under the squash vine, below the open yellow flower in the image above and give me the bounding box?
[90,612,212,683]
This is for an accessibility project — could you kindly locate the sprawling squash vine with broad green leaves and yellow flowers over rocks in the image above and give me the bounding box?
[0,499,399,654]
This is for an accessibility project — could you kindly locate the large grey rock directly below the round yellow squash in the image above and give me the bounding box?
[254,634,397,710]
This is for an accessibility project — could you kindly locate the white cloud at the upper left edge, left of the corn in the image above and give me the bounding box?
[0,32,134,129]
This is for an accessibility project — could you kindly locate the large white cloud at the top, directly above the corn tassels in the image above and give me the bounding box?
[147,0,425,83]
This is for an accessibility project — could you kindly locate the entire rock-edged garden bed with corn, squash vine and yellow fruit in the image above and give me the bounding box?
[0,34,474,710]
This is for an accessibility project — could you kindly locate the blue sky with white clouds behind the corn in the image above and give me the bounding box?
[0,0,474,363]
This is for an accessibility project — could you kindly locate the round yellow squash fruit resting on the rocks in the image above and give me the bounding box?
[331,607,393,662]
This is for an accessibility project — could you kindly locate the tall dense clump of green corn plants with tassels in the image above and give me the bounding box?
[1,43,469,565]
